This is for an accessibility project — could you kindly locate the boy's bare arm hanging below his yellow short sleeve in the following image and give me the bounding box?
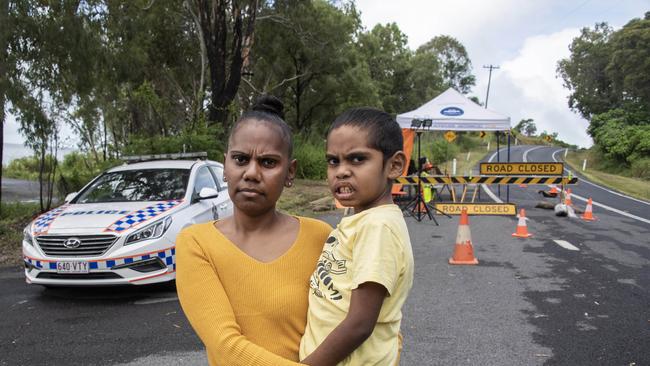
[301,282,388,366]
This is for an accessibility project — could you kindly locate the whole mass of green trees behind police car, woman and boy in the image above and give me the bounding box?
[0,0,480,209]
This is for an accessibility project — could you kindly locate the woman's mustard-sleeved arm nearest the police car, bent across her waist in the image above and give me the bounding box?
[176,233,299,366]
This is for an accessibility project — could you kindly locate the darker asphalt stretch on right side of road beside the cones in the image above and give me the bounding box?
[466,146,650,365]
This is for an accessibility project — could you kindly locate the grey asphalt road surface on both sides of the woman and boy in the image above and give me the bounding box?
[0,146,650,365]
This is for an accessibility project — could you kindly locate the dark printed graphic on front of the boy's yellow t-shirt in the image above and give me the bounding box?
[309,236,348,300]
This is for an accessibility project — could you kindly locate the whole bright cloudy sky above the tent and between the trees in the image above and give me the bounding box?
[356,0,650,147]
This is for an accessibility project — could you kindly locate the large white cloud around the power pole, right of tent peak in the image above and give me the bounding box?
[475,28,592,146]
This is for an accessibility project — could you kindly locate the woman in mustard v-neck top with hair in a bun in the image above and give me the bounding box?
[176,97,331,365]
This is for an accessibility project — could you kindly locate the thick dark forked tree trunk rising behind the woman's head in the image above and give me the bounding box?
[190,0,259,124]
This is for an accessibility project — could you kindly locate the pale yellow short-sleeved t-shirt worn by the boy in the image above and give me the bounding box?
[300,204,413,366]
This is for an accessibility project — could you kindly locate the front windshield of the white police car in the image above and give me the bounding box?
[74,169,190,203]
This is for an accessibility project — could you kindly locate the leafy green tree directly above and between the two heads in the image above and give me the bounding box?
[248,0,380,133]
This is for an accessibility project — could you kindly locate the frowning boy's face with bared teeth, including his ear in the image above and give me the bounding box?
[326,125,405,212]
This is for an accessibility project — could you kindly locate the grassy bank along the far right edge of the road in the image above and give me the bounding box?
[565,151,650,201]
